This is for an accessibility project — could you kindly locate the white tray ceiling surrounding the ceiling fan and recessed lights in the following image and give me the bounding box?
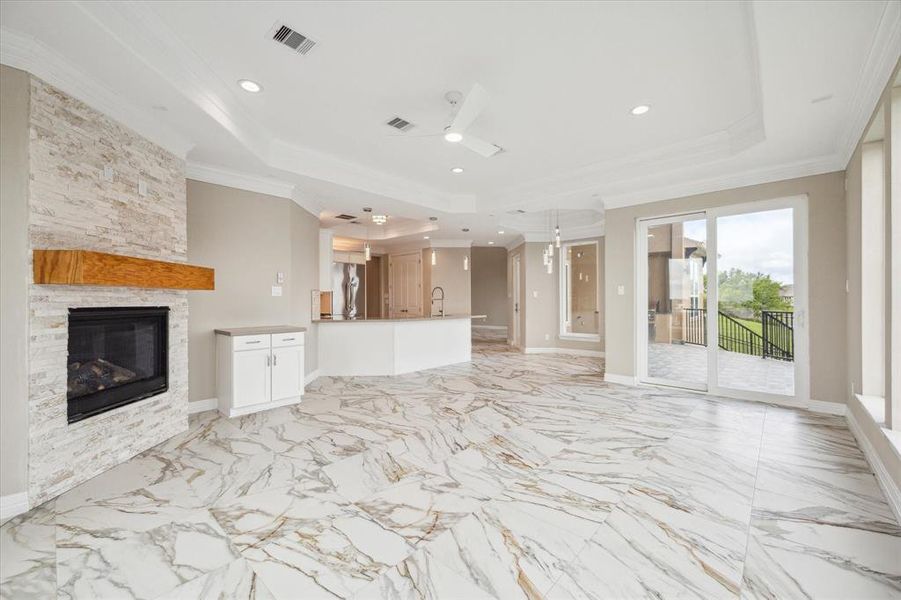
[0,0,901,243]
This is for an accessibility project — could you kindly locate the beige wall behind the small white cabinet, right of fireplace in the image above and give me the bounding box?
[187,180,319,401]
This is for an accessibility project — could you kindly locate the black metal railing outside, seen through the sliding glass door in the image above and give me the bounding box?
[682,308,794,361]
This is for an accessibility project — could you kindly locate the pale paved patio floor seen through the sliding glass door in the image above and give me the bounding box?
[648,343,795,396]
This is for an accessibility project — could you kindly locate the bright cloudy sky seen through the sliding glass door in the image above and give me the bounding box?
[685,208,794,285]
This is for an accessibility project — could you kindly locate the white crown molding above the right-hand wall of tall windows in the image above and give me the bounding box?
[838,1,901,169]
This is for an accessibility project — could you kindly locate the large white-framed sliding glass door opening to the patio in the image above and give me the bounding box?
[637,197,809,403]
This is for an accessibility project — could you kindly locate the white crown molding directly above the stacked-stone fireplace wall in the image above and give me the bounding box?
[0,27,194,159]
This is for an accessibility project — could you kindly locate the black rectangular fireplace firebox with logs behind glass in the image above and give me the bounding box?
[66,306,169,423]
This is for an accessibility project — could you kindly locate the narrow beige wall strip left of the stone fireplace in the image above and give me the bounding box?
[0,65,30,496]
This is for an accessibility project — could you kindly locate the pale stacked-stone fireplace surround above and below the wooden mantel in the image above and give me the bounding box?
[28,77,188,506]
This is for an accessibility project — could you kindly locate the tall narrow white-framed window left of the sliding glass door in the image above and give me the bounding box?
[560,242,600,341]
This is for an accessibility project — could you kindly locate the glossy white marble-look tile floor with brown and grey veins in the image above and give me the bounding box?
[0,343,901,599]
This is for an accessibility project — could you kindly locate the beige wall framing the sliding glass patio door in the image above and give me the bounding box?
[605,172,848,403]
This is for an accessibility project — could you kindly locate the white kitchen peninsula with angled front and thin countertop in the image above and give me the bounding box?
[314,315,485,376]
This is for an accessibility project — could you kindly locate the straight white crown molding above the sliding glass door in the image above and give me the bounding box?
[604,155,845,210]
